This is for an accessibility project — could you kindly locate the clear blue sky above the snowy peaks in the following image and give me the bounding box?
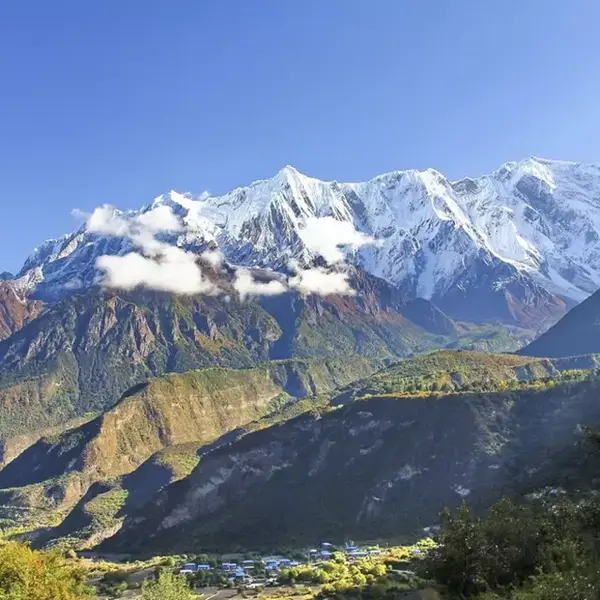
[0,0,600,271]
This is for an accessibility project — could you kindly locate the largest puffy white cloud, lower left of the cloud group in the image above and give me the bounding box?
[96,246,218,295]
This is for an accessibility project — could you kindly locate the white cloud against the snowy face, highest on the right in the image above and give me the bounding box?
[298,217,376,264]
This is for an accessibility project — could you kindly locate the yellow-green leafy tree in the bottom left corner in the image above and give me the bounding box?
[0,542,92,600]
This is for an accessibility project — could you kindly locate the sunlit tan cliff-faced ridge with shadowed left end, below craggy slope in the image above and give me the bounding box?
[0,357,381,518]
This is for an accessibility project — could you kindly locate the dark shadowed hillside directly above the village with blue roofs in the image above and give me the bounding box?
[102,379,600,551]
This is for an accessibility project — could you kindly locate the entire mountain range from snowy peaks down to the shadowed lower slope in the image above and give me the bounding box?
[0,158,600,551]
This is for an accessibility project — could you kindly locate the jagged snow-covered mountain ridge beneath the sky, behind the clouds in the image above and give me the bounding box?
[14,157,600,330]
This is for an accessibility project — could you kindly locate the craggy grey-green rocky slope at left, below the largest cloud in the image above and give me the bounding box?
[0,292,280,446]
